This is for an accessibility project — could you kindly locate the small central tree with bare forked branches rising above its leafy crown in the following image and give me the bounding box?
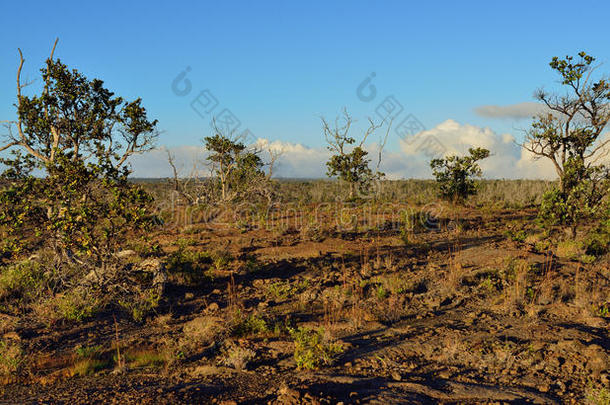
[322,110,384,199]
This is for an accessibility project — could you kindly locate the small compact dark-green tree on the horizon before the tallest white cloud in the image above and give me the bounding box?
[430,148,489,203]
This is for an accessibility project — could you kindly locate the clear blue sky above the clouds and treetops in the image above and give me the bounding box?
[0,1,610,177]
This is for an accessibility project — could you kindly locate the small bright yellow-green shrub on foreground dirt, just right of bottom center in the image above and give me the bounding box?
[289,327,343,370]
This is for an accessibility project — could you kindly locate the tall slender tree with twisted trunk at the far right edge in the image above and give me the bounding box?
[522,52,610,234]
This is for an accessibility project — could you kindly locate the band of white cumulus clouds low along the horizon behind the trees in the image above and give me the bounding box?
[126,120,556,179]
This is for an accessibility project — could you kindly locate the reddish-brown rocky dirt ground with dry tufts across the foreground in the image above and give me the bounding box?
[0,209,610,404]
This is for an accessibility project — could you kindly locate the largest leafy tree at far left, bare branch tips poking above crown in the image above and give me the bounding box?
[0,41,157,300]
